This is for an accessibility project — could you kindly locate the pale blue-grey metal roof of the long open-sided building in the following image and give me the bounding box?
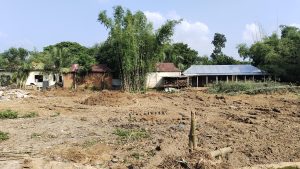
[183,65,265,76]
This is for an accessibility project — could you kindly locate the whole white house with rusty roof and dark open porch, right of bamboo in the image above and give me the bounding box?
[147,63,187,88]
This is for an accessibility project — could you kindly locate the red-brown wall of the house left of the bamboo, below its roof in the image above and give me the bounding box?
[63,73,112,90]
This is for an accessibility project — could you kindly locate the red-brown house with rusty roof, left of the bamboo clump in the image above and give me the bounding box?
[63,64,112,90]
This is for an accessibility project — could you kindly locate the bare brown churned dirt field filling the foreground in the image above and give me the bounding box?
[0,89,300,169]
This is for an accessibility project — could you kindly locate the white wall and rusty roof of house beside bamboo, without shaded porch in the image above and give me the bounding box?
[147,63,181,88]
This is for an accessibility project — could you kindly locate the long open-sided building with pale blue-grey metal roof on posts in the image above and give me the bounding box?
[183,65,267,87]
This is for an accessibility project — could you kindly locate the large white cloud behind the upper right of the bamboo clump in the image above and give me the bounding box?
[144,11,213,55]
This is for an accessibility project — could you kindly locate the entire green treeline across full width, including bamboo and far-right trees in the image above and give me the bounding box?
[0,6,300,91]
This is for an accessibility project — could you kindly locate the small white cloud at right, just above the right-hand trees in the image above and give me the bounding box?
[243,23,262,43]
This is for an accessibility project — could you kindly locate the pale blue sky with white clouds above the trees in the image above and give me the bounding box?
[0,0,300,58]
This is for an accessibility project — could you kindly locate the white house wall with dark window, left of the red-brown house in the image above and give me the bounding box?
[25,71,59,87]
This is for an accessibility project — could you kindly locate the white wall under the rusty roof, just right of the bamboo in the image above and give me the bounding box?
[147,72,181,88]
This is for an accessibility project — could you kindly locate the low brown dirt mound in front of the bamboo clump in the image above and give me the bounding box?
[80,91,136,107]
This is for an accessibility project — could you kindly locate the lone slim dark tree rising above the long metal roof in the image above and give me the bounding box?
[211,33,227,59]
